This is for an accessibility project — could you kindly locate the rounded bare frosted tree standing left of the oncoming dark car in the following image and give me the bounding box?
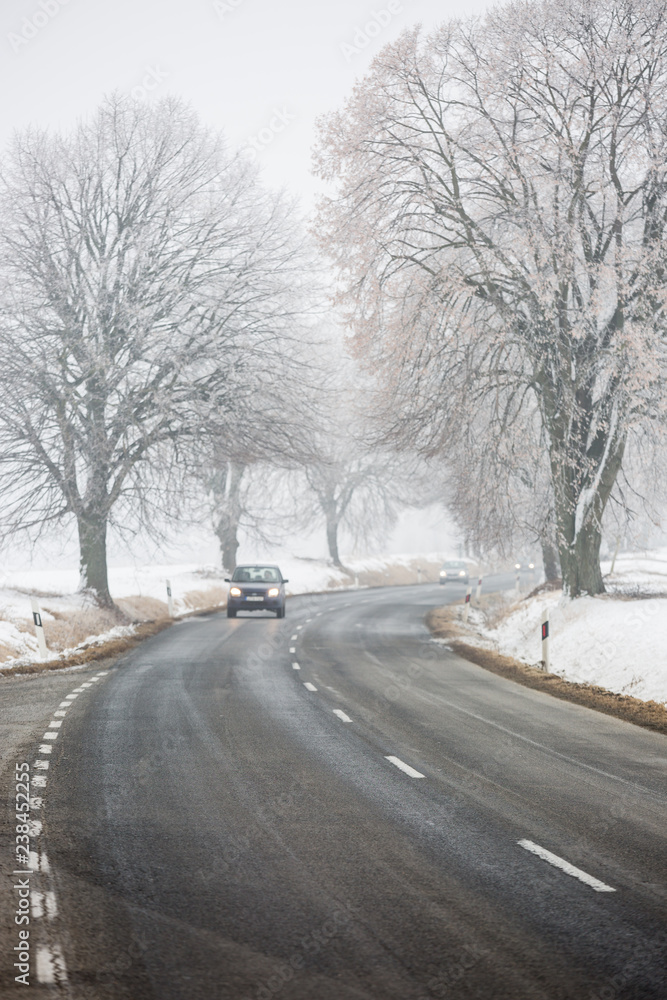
[0,96,310,604]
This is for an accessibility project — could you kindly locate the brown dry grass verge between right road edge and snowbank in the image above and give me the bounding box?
[426,604,667,736]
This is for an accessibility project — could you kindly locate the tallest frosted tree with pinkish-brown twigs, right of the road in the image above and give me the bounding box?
[317,0,667,596]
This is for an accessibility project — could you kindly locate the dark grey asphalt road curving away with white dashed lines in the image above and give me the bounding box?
[7,585,667,1000]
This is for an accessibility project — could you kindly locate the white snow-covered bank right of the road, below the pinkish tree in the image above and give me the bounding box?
[456,549,667,703]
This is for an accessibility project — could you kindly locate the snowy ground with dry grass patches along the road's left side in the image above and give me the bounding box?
[0,552,444,669]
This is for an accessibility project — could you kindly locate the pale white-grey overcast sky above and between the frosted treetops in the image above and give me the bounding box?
[0,0,496,204]
